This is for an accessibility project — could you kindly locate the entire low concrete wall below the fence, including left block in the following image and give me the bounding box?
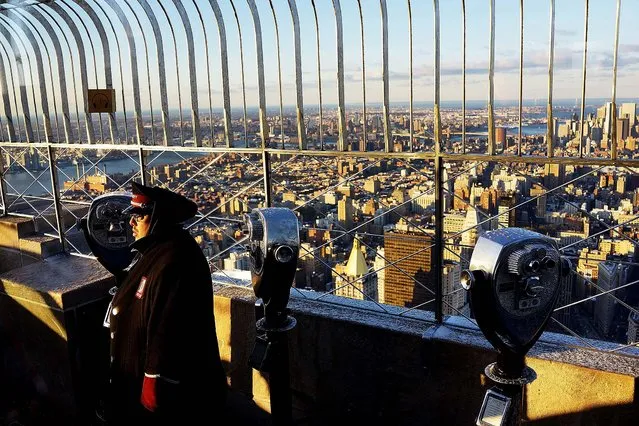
[0,251,639,426]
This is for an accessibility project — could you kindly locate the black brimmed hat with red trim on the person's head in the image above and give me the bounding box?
[124,182,197,223]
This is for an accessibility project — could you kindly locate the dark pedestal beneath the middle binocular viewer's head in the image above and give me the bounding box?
[249,315,297,426]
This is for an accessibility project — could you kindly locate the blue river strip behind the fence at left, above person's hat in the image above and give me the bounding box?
[5,151,203,196]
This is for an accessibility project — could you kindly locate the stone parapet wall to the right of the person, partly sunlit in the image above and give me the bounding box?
[215,287,639,426]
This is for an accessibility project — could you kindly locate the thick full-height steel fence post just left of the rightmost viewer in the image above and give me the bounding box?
[432,0,444,323]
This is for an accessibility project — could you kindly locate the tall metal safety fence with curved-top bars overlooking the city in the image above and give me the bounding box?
[0,0,639,355]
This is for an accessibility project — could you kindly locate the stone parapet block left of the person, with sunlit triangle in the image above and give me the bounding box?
[0,255,114,425]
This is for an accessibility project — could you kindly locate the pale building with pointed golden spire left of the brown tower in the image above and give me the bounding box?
[335,236,377,301]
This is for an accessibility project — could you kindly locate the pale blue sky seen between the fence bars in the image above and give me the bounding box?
[5,0,639,114]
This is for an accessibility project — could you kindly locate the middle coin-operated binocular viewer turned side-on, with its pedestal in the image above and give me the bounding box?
[243,208,300,425]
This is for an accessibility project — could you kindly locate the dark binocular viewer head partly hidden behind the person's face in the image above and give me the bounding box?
[79,192,135,277]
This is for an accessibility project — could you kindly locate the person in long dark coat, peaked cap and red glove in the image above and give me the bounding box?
[107,183,227,425]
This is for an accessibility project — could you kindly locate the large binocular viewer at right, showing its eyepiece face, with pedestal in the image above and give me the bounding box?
[461,228,570,426]
